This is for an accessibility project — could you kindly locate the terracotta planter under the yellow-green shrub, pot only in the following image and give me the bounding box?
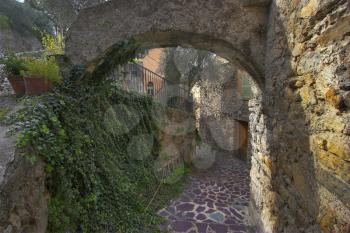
[24,77,53,95]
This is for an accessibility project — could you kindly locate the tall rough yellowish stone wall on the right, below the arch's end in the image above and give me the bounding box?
[250,0,350,233]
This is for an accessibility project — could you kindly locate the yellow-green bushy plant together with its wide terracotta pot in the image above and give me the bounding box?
[23,57,62,95]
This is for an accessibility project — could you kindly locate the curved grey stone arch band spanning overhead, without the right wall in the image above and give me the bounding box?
[66,0,267,86]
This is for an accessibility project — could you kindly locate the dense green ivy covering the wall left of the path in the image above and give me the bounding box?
[4,40,175,233]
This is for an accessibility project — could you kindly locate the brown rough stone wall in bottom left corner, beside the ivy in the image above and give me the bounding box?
[0,155,48,233]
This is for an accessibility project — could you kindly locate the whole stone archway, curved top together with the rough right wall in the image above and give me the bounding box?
[66,0,350,232]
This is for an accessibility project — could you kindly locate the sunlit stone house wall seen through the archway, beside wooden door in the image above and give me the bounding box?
[192,67,253,161]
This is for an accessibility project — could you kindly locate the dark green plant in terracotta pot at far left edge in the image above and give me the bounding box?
[0,54,25,95]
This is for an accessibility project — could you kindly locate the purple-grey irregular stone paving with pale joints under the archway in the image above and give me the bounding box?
[159,155,253,233]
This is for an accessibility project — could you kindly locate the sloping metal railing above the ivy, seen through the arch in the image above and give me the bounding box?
[112,62,192,111]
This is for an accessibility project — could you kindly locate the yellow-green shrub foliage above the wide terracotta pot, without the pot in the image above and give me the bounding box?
[22,58,62,83]
